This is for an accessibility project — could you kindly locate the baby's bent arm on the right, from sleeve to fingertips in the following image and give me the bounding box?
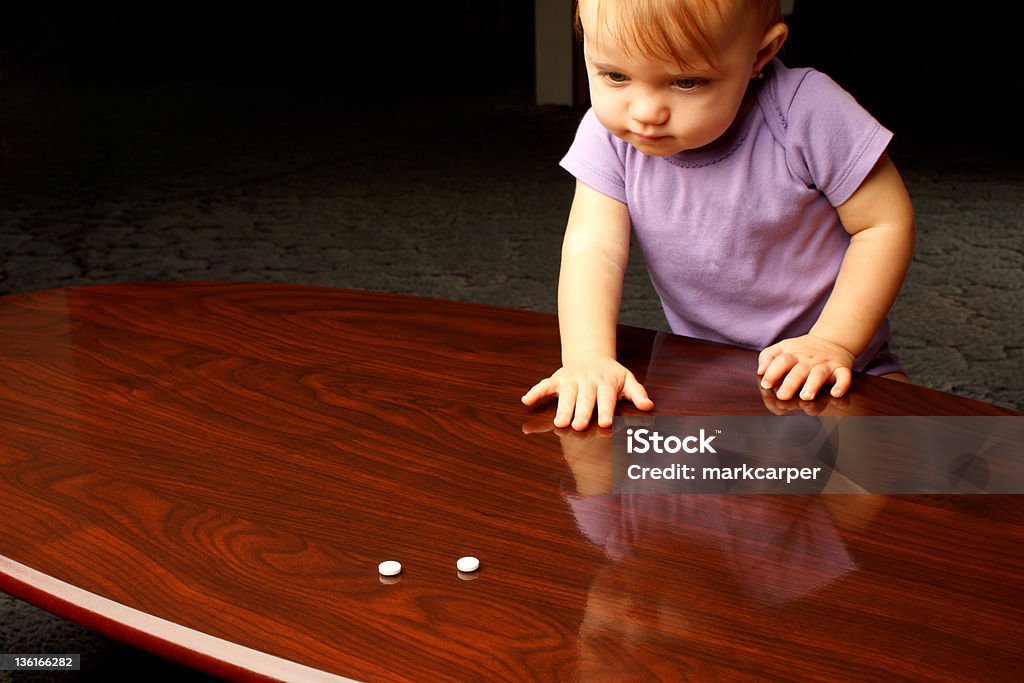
[758,155,913,400]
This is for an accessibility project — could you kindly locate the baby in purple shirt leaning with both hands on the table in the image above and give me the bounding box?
[522,0,913,429]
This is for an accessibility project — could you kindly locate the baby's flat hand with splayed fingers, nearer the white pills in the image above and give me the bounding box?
[522,354,654,431]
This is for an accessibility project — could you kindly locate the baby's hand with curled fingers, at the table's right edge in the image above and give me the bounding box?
[758,335,854,400]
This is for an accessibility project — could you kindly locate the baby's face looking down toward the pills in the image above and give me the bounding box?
[580,2,764,157]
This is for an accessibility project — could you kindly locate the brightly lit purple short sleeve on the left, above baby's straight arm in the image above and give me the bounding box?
[559,109,626,204]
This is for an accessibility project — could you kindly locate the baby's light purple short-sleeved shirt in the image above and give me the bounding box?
[561,59,902,374]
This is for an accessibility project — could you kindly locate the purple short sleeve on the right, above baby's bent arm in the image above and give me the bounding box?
[783,71,892,207]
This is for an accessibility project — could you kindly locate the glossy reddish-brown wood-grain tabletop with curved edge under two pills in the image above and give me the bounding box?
[0,283,1024,681]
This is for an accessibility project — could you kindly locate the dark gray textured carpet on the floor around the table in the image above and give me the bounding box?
[0,73,1024,681]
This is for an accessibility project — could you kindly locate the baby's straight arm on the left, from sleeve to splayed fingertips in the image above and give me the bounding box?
[522,181,654,430]
